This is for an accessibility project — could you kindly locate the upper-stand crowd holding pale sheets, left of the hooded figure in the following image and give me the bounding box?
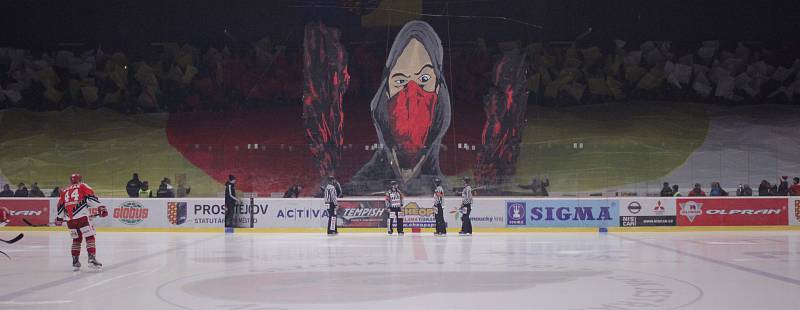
[0,39,302,113]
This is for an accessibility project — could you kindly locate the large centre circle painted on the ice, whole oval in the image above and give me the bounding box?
[157,261,702,310]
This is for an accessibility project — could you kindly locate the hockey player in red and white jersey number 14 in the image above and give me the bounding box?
[55,173,108,271]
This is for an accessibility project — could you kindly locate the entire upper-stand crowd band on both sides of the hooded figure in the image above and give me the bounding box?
[0,38,800,113]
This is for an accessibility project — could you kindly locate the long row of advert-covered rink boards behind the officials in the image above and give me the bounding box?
[0,197,800,232]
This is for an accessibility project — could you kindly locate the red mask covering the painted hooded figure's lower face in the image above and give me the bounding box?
[387,82,438,168]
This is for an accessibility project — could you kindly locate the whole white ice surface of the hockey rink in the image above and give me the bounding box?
[0,231,800,310]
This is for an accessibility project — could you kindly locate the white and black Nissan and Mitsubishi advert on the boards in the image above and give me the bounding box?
[619,197,677,227]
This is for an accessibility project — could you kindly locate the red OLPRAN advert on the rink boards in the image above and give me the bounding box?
[677,197,789,226]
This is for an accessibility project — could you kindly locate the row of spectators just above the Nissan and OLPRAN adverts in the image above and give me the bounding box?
[660,176,800,197]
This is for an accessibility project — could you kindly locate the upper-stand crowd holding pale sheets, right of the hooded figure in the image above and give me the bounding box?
[526,40,800,104]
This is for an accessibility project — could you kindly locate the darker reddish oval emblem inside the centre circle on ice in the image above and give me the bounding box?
[183,271,600,303]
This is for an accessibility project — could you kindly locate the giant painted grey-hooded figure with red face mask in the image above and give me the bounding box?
[345,20,452,195]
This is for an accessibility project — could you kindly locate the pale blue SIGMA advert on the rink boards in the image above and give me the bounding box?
[506,199,619,227]
